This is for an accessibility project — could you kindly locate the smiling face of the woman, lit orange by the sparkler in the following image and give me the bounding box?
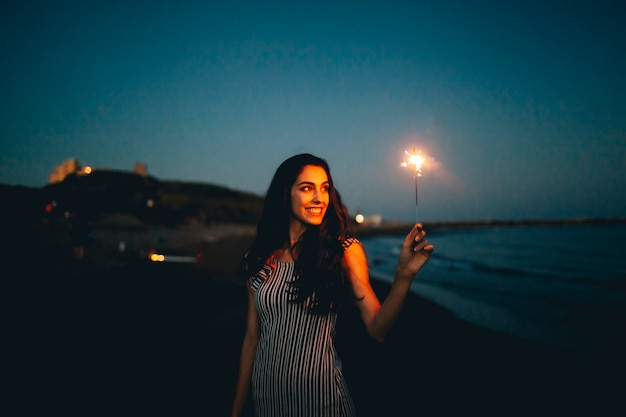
[291,165,329,226]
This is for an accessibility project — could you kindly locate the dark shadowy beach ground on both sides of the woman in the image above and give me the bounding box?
[5,219,626,416]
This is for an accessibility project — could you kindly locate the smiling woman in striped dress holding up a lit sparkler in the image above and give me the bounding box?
[232,154,433,417]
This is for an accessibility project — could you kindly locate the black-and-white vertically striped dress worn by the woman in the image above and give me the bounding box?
[251,240,355,417]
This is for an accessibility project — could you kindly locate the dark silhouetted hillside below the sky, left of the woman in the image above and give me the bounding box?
[0,171,263,227]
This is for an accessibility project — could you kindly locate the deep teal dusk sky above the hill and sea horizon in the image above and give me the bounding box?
[0,0,626,221]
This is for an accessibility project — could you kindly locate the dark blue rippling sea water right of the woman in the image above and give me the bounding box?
[361,223,626,351]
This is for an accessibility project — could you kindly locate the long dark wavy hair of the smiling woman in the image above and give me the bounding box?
[242,153,352,314]
